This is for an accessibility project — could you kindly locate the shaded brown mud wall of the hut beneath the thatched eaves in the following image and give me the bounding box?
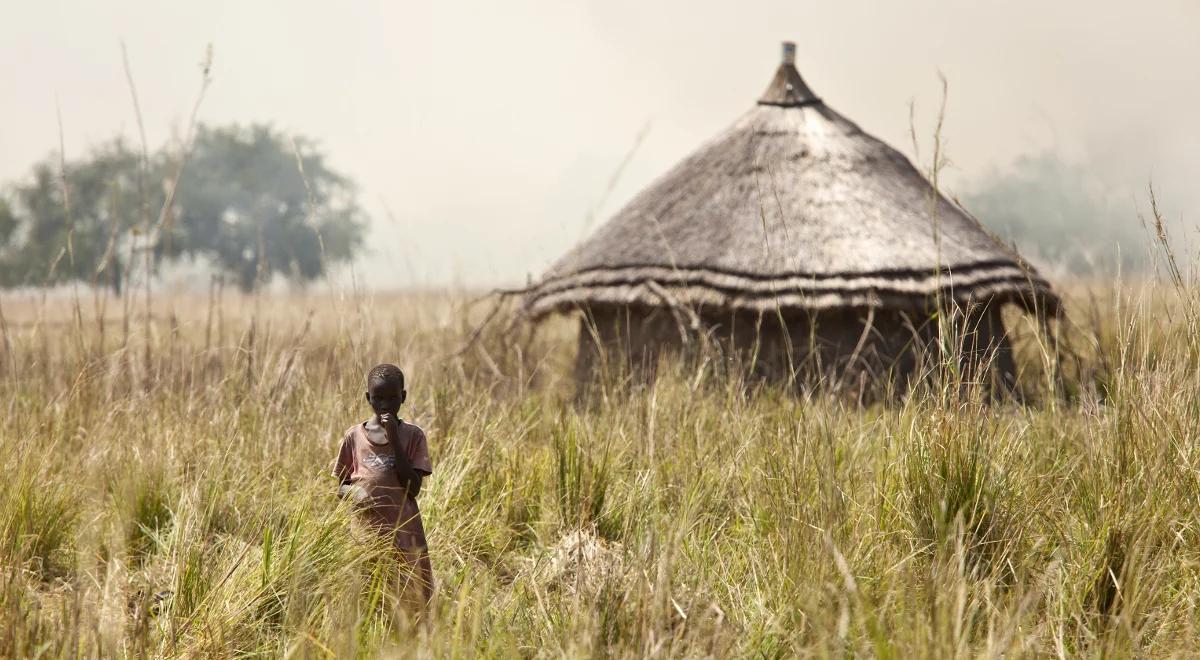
[576,304,1015,398]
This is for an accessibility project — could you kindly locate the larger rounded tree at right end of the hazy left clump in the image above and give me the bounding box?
[175,125,365,290]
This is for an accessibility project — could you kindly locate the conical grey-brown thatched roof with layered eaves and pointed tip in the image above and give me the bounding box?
[524,44,1057,317]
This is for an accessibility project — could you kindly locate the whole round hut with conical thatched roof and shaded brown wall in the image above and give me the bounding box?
[523,43,1057,396]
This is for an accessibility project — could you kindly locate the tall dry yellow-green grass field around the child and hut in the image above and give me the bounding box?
[0,272,1200,658]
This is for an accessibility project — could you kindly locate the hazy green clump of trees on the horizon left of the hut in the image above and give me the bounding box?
[0,125,366,290]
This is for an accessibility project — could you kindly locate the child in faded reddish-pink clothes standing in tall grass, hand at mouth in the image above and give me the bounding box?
[334,364,433,605]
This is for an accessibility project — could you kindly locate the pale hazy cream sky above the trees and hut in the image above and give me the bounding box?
[0,0,1200,287]
